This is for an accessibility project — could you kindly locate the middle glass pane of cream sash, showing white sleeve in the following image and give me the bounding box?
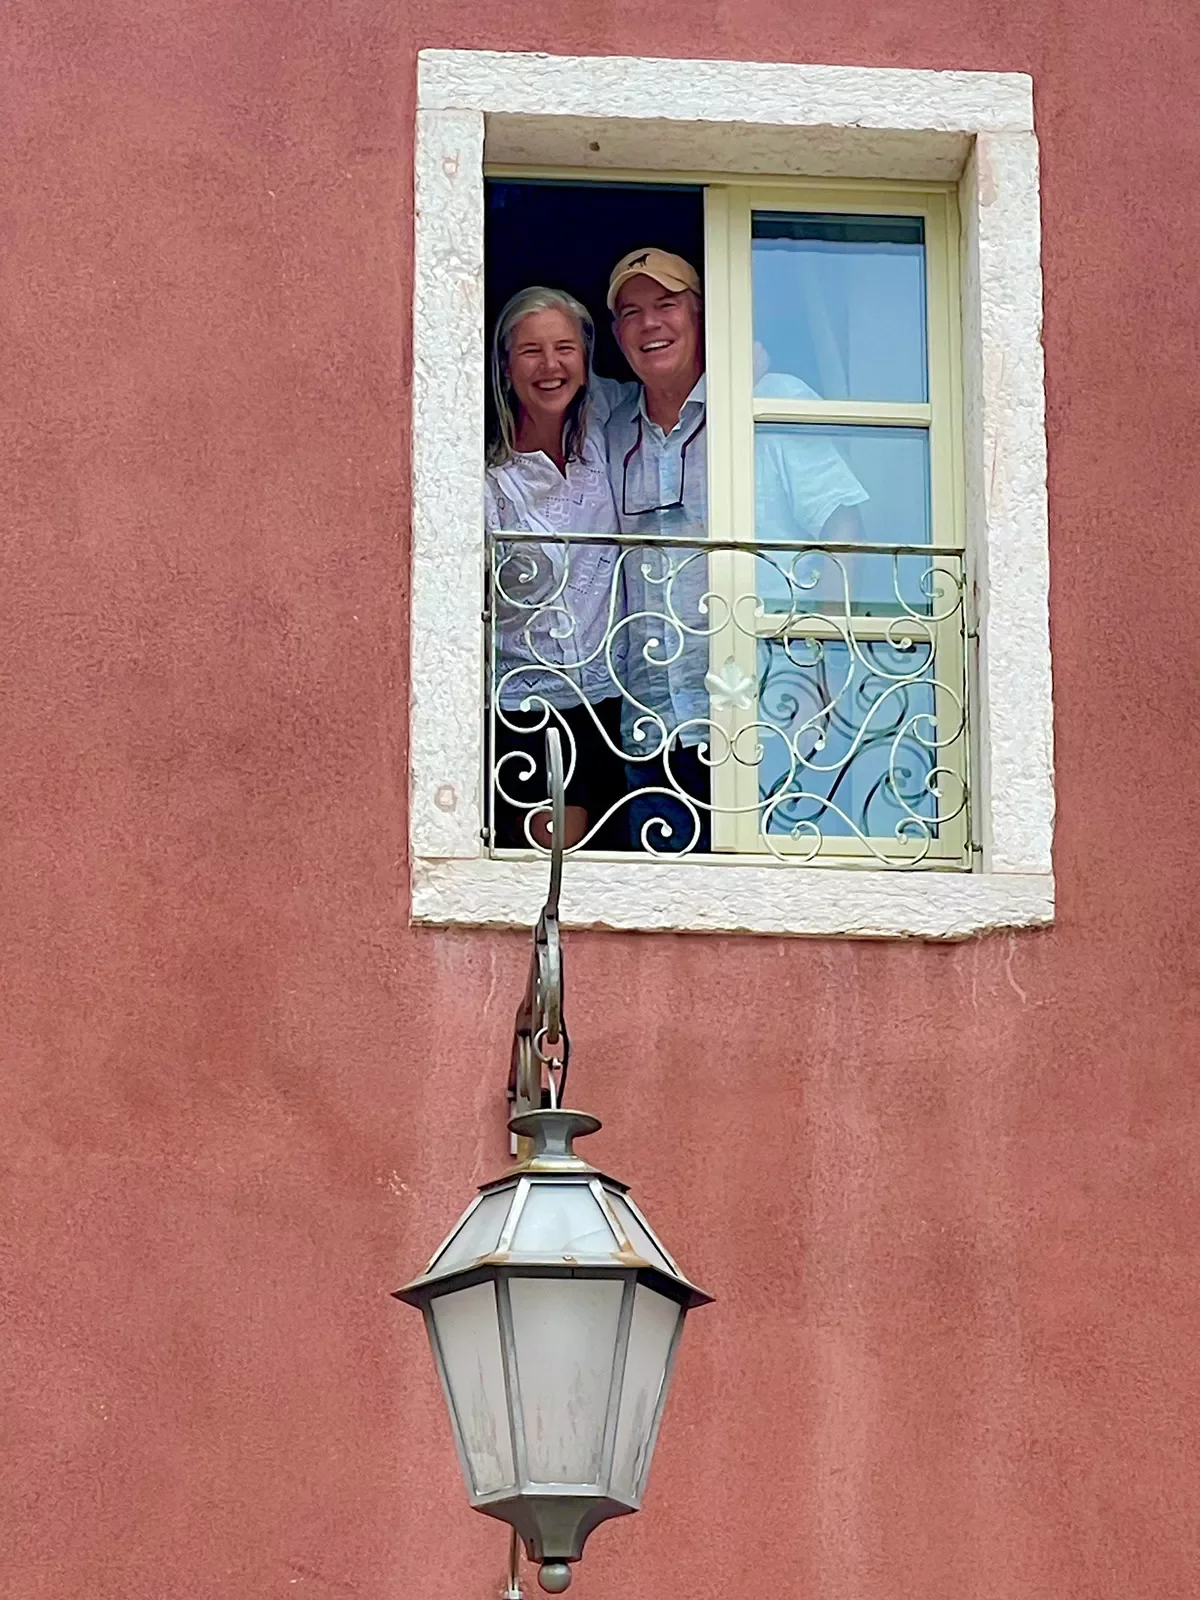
[754,422,931,614]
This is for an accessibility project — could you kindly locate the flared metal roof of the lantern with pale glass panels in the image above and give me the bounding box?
[395,1109,712,1309]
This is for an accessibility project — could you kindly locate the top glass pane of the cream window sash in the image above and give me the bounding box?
[752,211,928,402]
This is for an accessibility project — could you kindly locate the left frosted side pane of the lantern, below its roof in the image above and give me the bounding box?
[430,1283,515,1496]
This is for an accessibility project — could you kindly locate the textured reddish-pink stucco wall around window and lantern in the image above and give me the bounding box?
[0,0,1200,1600]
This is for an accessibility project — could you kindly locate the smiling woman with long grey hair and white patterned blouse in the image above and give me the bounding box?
[485,288,624,848]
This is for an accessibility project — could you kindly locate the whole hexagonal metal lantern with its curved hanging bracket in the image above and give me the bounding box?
[395,731,710,1597]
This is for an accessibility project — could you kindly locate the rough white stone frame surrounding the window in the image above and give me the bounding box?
[410,50,1054,939]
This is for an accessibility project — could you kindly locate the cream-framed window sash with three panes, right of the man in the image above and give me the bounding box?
[709,186,971,869]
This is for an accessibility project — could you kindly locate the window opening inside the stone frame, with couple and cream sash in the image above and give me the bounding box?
[485,176,971,869]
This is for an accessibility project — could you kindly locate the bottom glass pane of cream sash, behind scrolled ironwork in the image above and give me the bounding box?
[757,630,963,848]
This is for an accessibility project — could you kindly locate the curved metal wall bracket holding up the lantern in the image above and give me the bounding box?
[509,728,571,1114]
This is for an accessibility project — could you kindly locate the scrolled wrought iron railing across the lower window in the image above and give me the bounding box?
[486,533,971,869]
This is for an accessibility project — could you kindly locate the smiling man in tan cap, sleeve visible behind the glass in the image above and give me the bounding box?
[606,250,867,851]
